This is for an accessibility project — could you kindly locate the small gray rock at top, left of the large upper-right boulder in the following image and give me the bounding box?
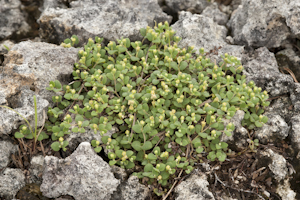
[201,3,228,26]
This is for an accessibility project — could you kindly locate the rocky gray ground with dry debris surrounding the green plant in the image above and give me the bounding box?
[0,0,300,200]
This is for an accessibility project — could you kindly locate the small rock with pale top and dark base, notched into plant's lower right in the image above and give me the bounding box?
[220,110,248,150]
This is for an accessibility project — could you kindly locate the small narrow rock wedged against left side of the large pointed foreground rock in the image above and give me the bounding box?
[29,155,45,184]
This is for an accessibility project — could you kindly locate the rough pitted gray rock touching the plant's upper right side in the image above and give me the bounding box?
[242,47,295,97]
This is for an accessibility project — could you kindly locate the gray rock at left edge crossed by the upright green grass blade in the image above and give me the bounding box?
[0,89,49,135]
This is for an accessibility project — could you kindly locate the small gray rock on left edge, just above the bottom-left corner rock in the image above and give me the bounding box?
[0,140,18,169]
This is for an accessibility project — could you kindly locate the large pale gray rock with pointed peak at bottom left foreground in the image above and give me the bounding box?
[40,142,120,200]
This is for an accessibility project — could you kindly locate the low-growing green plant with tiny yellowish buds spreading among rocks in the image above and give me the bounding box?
[21,22,269,193]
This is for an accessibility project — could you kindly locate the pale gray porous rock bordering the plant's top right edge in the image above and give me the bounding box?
[172,11,244,63]
